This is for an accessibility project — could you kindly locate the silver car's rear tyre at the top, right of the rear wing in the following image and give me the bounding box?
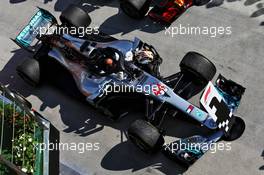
[60,5,91,28]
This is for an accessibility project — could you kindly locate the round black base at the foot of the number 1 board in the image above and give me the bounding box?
[222,116,246,141]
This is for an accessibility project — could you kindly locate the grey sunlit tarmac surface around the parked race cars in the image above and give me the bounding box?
[0,0,264,175]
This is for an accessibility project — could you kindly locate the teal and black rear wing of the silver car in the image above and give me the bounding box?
[12,7,57,51]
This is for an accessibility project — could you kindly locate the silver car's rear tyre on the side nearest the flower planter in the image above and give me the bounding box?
[16,59,40,86]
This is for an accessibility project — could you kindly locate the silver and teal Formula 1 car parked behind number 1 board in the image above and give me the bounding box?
[14,6,245,165]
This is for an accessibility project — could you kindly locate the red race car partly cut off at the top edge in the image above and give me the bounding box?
[120,0,210,24]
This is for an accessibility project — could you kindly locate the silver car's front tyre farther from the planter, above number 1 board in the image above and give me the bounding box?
[180,52,216,84]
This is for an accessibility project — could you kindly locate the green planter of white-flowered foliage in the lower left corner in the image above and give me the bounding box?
[0,93,43,175]
